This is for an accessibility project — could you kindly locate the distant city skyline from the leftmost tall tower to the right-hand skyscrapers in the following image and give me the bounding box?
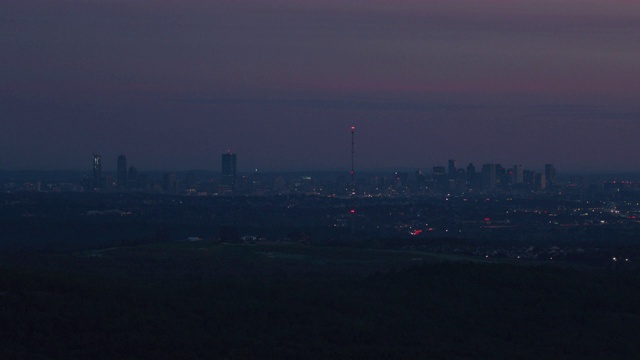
[71,151,557,196]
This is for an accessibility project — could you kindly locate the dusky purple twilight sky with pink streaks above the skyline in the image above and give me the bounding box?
[0,0,640,172]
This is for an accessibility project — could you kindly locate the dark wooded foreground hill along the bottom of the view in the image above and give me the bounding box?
[0,242,640,359]
